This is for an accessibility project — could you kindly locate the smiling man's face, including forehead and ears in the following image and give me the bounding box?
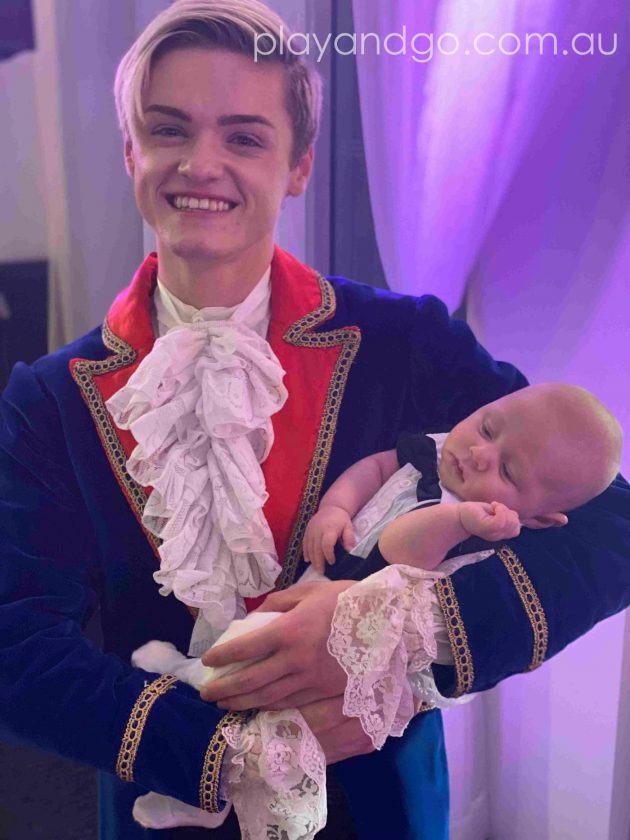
[125,48,312,266]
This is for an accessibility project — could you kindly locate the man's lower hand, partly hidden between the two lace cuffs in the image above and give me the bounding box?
[299,695,374,764]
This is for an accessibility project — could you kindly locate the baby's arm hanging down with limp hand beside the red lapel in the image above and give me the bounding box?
[303,449,399,574]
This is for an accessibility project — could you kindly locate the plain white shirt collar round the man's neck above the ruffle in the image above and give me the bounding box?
[153,266,271,338]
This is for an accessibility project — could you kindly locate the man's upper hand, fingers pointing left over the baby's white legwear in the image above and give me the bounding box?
[200,580,355,711]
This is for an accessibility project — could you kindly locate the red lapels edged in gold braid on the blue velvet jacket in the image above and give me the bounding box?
[71,247,360,585]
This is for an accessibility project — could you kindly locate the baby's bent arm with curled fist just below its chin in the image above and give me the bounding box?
[378,502,521,569]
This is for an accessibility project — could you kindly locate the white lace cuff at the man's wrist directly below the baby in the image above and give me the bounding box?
[328,551,492,749]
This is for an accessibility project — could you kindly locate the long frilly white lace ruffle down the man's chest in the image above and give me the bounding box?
[107,320,287,630]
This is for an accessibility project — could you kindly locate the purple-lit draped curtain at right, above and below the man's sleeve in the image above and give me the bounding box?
[353,0,630,840]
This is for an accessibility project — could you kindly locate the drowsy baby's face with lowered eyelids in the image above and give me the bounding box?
[439,388,576,523]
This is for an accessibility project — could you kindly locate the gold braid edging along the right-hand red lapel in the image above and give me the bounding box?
[276,276,361,589]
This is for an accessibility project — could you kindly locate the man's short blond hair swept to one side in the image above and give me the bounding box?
[114,0,321,166]
